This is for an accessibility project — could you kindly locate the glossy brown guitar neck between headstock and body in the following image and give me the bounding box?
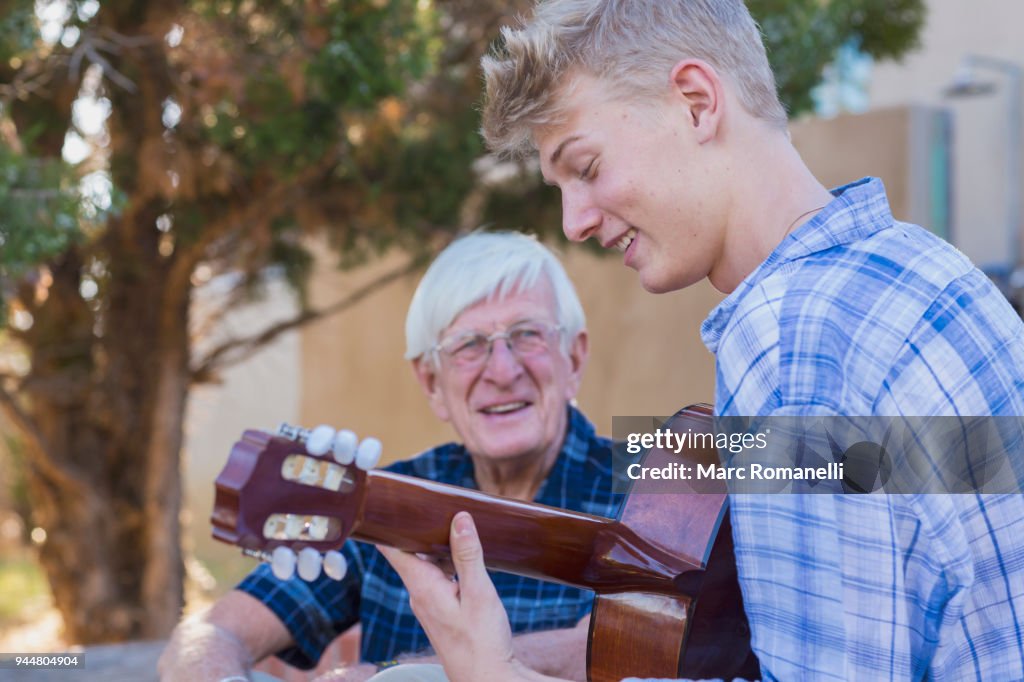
[351,471,696,594]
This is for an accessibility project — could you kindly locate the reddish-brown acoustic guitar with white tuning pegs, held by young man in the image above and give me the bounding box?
[211,406,760,682]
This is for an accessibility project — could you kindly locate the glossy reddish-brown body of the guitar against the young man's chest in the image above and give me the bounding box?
[587,406,761,682]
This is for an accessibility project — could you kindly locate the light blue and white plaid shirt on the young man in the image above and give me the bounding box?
[630,178,1024,682]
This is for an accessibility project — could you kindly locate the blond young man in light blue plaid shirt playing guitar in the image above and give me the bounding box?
[385,0,1024,681]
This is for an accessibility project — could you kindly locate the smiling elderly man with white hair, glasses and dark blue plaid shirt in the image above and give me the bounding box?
[160,232,617,682]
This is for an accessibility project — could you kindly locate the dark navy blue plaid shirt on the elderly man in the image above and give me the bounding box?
[238,408,620,669]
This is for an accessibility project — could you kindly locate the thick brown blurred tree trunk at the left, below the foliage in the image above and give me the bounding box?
[25,232,190,643]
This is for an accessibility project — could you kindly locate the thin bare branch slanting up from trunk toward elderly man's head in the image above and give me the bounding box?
[190,250,425,384]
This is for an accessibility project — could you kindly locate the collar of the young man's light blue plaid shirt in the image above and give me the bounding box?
[700,177,893,353]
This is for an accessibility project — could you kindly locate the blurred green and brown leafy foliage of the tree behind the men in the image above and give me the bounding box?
[0,0,924,303]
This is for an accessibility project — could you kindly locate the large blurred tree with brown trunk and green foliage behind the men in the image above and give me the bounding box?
[0,0,922,642]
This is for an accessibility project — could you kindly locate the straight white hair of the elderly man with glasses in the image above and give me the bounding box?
[406,231,587,359]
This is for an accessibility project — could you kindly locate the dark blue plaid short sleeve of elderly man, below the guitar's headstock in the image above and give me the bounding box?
[237,542,364,670]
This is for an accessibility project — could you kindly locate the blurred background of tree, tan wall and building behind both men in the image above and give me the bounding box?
[0,0,1024,679]
